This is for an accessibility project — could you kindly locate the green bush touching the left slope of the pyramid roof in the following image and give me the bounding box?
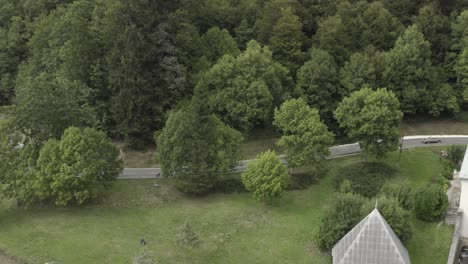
[315,193,367,251]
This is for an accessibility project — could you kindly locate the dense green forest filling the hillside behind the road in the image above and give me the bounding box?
[0,0,468,148]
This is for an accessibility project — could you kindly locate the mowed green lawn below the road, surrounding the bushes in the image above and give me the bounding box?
[0,149,453,264]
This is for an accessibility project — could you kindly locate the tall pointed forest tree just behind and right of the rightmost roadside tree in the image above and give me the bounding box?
[381,26,435,114]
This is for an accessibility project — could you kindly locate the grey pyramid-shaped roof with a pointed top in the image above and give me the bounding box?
[332,209,410,264]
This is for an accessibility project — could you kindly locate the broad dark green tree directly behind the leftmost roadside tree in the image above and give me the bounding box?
[12,73,95,144]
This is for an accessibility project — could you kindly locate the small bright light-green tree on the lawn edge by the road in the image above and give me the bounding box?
[242,150,289,202]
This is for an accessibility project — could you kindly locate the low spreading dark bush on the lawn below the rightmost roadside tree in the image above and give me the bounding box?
[336,162,395,197]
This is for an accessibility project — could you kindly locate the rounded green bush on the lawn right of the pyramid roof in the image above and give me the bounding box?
[414,184,448,221]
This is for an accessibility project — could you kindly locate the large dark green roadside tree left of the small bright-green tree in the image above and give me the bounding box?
[156,103,242,195]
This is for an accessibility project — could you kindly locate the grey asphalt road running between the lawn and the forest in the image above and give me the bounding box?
[117,135,468,179]
